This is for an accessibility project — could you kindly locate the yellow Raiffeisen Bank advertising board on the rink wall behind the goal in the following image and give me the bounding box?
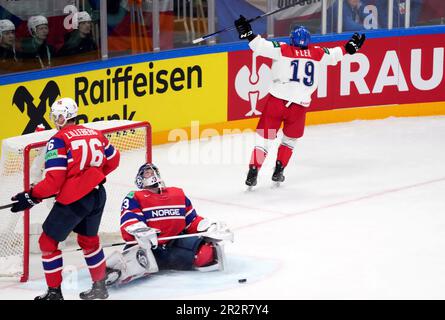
[0,53,228,143]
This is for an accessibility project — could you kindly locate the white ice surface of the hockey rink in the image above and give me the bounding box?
[0,116,445,300]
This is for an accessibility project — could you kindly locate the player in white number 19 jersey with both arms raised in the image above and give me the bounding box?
[235,16,365,187]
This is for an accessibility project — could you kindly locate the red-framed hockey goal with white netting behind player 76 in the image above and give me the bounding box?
[0,120,151,282]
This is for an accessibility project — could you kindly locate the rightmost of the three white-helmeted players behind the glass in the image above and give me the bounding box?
[58,11,97,56]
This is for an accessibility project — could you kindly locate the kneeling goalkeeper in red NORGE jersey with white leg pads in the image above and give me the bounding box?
[106,163,233,285]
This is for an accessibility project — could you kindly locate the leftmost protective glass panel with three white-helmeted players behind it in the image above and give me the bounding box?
[0,0,100,74]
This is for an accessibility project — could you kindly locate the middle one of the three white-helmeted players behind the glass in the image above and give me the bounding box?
[21,16,55,69]
